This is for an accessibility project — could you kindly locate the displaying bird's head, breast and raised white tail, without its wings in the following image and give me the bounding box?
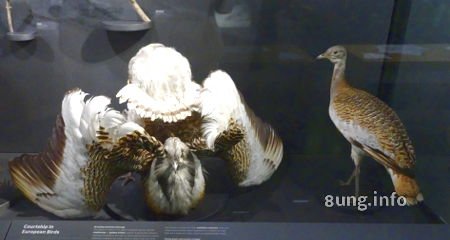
[117,43,205,215]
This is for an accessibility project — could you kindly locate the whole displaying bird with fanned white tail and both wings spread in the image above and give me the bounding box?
[10,44,283,218]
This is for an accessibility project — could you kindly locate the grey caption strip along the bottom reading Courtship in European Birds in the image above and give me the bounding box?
[0,221,450,240]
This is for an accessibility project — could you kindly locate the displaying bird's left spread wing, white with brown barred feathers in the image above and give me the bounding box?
[9,89,162,218]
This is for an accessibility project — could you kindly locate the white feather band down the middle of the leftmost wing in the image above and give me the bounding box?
[48,90,97,217]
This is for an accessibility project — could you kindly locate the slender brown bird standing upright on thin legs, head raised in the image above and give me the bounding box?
[317,46,423,205]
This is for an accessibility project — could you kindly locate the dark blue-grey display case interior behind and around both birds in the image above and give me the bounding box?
[0,0,450,226]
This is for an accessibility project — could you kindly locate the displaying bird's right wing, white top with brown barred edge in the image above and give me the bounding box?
[201,71,283,187]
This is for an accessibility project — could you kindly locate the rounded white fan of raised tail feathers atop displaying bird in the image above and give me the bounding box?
[117,44,200,122]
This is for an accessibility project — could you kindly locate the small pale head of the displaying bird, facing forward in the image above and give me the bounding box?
[164,137,193,171]
